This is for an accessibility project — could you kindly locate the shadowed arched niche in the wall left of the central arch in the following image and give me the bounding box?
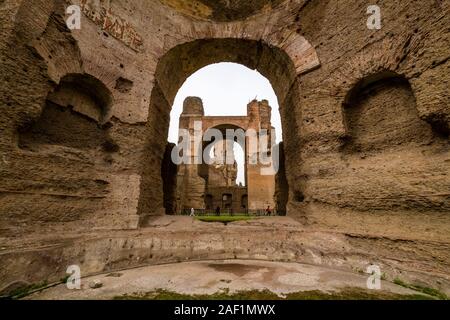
[19,74,117,152]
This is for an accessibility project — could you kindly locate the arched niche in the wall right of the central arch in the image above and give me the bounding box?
[344,71,442,152]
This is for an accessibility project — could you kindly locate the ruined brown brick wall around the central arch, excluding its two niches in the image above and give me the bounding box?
[1,0,449,231]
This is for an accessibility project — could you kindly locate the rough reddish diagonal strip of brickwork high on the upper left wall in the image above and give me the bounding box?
[81,0,143,51]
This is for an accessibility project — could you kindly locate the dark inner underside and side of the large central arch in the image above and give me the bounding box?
[138,39,310,221]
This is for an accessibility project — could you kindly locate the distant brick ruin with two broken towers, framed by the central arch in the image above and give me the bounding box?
[176,97,283,213]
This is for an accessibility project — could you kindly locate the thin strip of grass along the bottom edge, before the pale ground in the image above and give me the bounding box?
[114,288,432,300]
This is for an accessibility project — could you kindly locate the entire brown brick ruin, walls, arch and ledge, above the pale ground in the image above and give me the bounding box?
[0,0,450,295]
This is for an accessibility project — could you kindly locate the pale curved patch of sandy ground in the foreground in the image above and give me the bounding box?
[27,260,417,299]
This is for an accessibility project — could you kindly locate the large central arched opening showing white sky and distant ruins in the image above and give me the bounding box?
[169,63,282,213]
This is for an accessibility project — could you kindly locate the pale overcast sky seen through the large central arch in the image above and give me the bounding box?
[169,62,281,183]
